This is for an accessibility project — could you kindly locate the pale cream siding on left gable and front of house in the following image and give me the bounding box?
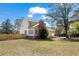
[18,20,37,36]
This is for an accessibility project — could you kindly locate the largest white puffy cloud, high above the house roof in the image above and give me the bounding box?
[29,7,47,15]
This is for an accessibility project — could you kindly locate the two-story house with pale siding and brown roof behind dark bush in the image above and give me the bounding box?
[18,20,53,38]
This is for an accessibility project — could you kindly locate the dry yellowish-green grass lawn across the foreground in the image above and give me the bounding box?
[0,39,79,56]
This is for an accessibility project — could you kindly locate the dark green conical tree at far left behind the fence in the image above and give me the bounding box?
[0,19,15,34]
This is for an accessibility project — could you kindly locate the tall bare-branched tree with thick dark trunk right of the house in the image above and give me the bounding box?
[47,3,79,38]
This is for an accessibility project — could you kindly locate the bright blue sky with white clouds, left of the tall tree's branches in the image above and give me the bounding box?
[0,3,49,23]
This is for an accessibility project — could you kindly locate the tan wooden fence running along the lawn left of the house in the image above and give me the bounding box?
[0,34,26,40]
